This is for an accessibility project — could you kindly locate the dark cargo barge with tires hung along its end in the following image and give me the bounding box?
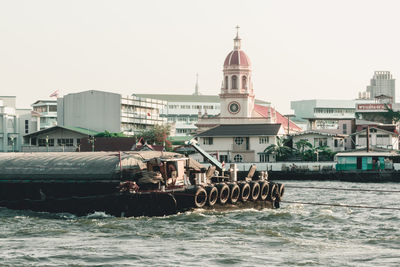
[0,151,284,217]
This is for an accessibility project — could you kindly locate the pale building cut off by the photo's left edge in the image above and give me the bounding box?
[0,96,38,152]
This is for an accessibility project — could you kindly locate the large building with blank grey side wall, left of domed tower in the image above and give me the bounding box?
[57,90,167,135]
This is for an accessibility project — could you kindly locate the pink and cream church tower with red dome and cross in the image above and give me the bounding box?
[220,26,254,119]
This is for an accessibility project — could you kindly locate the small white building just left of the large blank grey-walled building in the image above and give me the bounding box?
[31,100,57,130]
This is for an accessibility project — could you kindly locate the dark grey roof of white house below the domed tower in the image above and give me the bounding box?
[197,124,281,137]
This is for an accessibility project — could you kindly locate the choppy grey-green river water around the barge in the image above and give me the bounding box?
[0,181,400,266]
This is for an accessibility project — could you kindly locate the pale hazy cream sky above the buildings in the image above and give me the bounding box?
[0,0,400,114]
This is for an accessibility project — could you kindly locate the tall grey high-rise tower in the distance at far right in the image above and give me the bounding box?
[366,71,396,103]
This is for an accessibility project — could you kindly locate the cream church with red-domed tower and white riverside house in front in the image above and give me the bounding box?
[196,27,301,162]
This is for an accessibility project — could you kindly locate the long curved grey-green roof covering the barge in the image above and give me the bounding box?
[0,151,199,182]
